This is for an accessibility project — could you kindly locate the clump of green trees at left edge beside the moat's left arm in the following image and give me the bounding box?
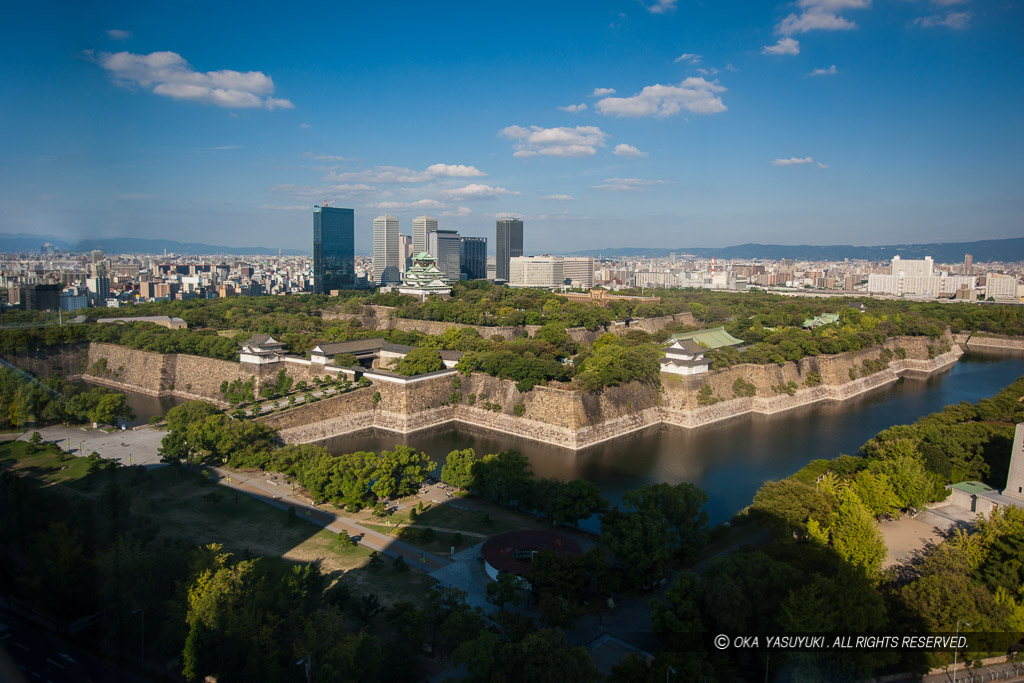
[0,368,135,429]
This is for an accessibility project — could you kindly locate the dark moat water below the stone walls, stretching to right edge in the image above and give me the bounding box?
[323,351,1024,524]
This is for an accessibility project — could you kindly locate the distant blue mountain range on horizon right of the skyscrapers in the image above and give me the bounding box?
[572,238,1024,263]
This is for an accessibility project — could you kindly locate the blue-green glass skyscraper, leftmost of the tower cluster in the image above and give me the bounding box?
[313,206,355,294]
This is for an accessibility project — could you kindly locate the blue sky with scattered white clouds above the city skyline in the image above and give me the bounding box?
[0,0,1024,253]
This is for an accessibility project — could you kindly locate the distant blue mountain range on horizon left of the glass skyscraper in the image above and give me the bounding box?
[0,232,309,256]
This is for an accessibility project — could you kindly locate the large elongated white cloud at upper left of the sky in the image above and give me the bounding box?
[98,52,294,110]
